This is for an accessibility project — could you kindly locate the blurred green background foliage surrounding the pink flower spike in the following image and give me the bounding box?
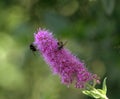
[0,0,120,99]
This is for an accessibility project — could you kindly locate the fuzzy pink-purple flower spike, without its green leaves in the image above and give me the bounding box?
[33,29,99,88]
